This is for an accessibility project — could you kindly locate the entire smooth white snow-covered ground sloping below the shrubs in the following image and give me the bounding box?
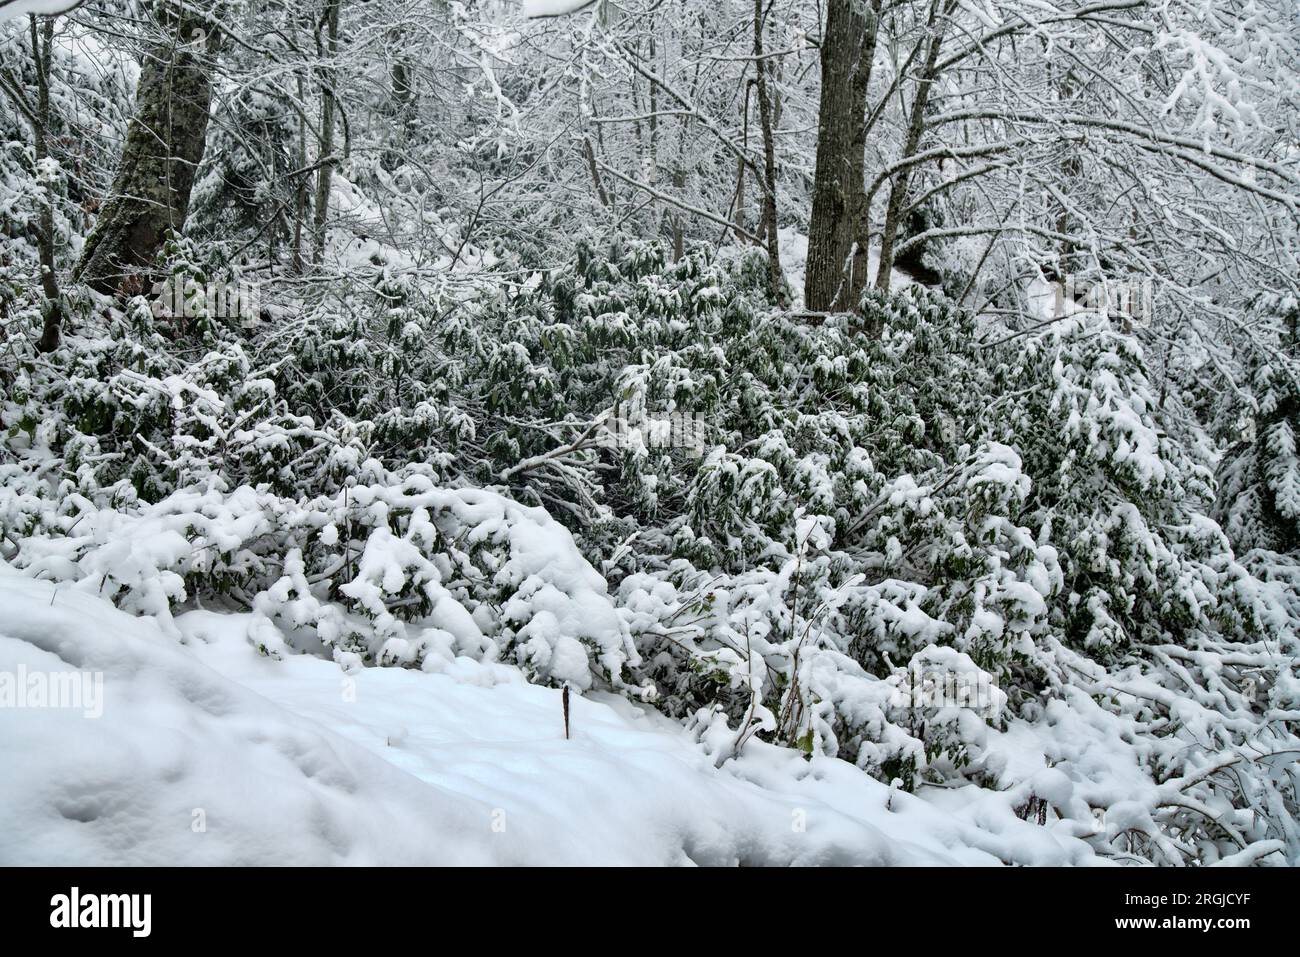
[0,564,1087,865]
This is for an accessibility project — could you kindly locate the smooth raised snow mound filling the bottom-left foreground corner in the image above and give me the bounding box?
[0,564,493,865]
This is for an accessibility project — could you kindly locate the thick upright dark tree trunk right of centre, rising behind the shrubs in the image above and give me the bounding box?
[803,0,880,312]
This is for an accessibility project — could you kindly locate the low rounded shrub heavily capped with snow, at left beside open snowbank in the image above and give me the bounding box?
[3,476,638,688]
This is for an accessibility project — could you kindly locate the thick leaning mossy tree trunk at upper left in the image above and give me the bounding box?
[75,0,221,294]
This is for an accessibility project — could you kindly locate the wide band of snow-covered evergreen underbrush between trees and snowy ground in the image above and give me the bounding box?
[0,242,1300,863]
